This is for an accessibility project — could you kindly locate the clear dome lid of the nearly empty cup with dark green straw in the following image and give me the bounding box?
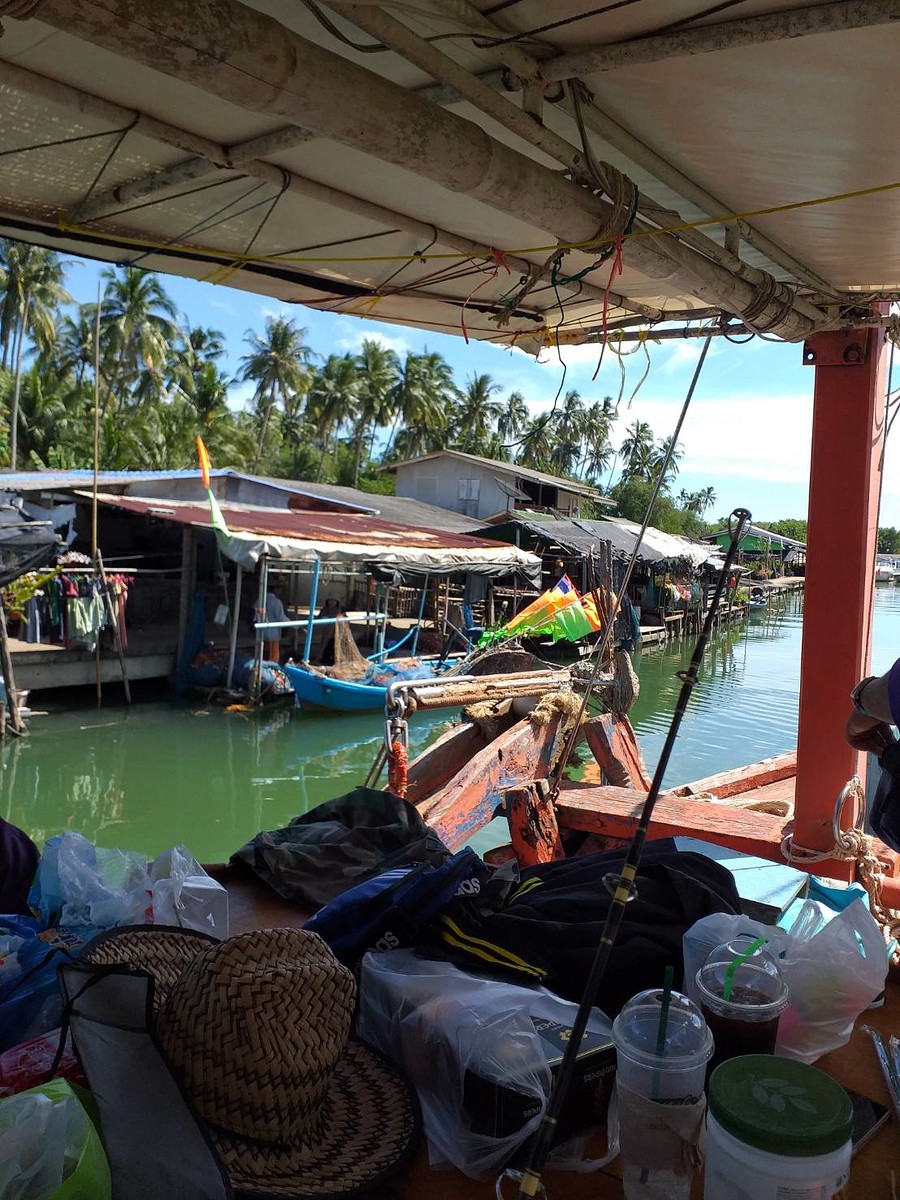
[612,988,713,1070]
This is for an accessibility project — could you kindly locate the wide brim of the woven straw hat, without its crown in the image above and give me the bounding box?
[82,925,421,1200]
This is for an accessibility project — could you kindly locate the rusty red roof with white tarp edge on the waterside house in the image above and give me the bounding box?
[90,493,540,583]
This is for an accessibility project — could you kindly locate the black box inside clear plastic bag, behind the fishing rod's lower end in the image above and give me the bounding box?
[463,1016,616,1146]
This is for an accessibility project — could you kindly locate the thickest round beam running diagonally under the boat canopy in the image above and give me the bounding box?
[0,0,828,341]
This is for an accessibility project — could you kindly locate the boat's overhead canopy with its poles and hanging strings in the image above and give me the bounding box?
[0,0,900,352]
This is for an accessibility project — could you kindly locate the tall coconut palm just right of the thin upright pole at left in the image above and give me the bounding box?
[100,266,179,412]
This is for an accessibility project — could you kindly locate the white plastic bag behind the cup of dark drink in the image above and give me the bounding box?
[683,899,888,1063]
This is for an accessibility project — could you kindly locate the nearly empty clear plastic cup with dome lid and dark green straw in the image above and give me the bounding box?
[612,989,713,1200]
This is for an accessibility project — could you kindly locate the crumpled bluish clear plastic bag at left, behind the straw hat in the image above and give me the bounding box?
[29,830,151,929]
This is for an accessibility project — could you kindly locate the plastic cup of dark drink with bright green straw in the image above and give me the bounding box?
[696,959,788,1070]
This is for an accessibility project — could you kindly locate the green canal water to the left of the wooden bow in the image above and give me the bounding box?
[0,702,446,862]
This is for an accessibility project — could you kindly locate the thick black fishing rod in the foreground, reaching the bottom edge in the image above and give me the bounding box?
[508,509,750,1200]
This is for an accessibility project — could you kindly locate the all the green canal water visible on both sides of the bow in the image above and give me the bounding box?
[0,587,900,862]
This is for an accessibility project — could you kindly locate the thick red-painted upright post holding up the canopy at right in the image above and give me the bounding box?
[794,329,887,878]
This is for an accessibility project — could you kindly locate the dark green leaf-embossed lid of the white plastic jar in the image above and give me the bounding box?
[708,1054,853,1158]
